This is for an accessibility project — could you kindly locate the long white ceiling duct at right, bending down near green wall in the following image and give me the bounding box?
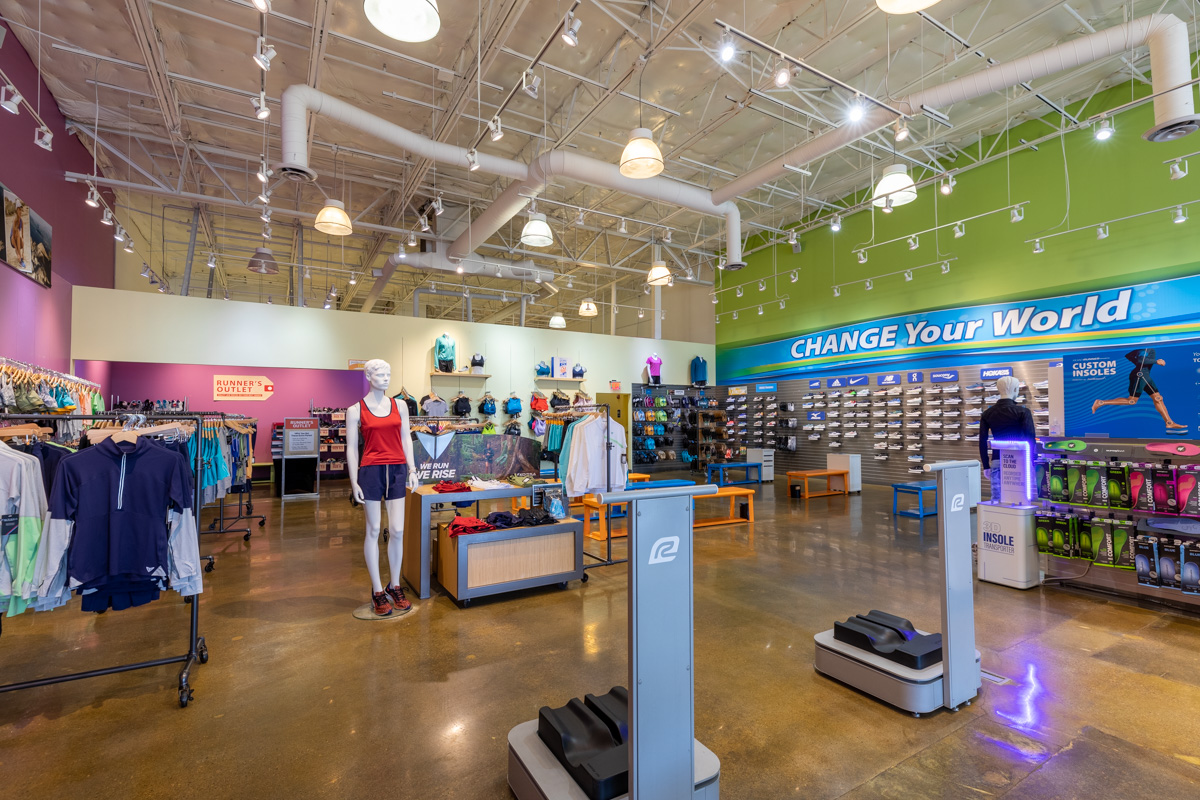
[713,14,1200,203]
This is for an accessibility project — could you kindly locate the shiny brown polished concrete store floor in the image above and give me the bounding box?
[0,485,1200,800]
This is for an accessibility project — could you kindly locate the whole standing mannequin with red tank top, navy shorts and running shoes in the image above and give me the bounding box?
[346,359,420,616]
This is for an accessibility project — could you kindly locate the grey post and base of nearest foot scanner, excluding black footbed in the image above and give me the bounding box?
[509,485,721,800]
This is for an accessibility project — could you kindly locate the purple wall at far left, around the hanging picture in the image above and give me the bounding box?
[0,21,114,372]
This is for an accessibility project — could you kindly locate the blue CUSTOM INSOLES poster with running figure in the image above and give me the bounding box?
[1062,342,1200,441]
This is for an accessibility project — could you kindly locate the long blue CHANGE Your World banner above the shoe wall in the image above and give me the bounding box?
[718,276,1200,383]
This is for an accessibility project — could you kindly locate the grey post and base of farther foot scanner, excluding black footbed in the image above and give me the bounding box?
[814,461,982,716]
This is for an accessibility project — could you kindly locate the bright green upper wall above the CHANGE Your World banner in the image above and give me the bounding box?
[715,85,1200,350]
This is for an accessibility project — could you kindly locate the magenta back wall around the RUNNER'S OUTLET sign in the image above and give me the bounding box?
[76,361,367,461]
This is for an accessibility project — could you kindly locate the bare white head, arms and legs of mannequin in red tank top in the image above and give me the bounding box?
[346,359,421,604]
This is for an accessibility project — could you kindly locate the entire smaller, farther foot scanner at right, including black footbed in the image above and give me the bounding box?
[814,461,982,716]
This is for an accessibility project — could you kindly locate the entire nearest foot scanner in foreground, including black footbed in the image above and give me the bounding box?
[509,485,721,800]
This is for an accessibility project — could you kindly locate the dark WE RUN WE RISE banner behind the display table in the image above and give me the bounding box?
[413,431,541,482]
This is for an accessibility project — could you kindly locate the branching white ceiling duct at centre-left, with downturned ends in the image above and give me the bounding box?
[278,84,742,269]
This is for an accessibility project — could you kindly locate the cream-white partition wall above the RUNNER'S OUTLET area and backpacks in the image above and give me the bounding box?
[71,287,715,395]
